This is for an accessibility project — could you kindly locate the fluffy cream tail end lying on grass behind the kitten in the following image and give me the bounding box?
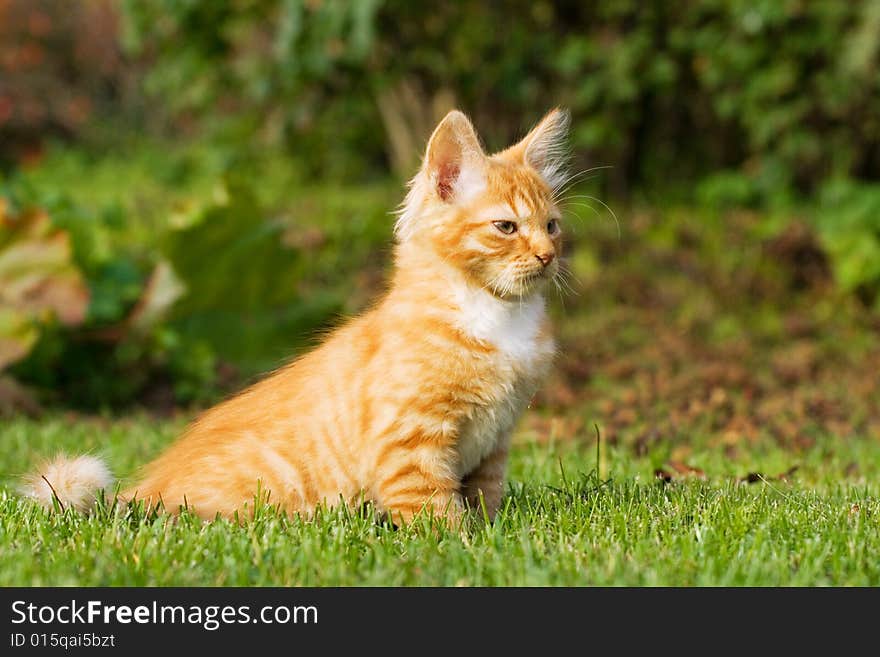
[21,455,113,511]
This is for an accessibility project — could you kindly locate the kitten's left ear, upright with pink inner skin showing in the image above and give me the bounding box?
[422,110,486,202]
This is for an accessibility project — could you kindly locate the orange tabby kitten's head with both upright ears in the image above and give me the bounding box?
[396,109,568,299]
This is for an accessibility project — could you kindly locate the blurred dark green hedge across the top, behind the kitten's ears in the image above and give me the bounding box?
[118,0,880,194]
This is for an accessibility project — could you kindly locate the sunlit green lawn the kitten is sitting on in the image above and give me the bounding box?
[0,417,880,586]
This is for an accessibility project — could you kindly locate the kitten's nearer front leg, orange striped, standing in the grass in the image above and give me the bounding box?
[375,437,463,529]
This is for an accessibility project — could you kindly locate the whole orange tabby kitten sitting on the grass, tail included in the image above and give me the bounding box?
[26,110,568,523]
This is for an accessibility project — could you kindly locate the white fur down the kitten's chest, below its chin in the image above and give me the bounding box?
[456,289,553,476]
